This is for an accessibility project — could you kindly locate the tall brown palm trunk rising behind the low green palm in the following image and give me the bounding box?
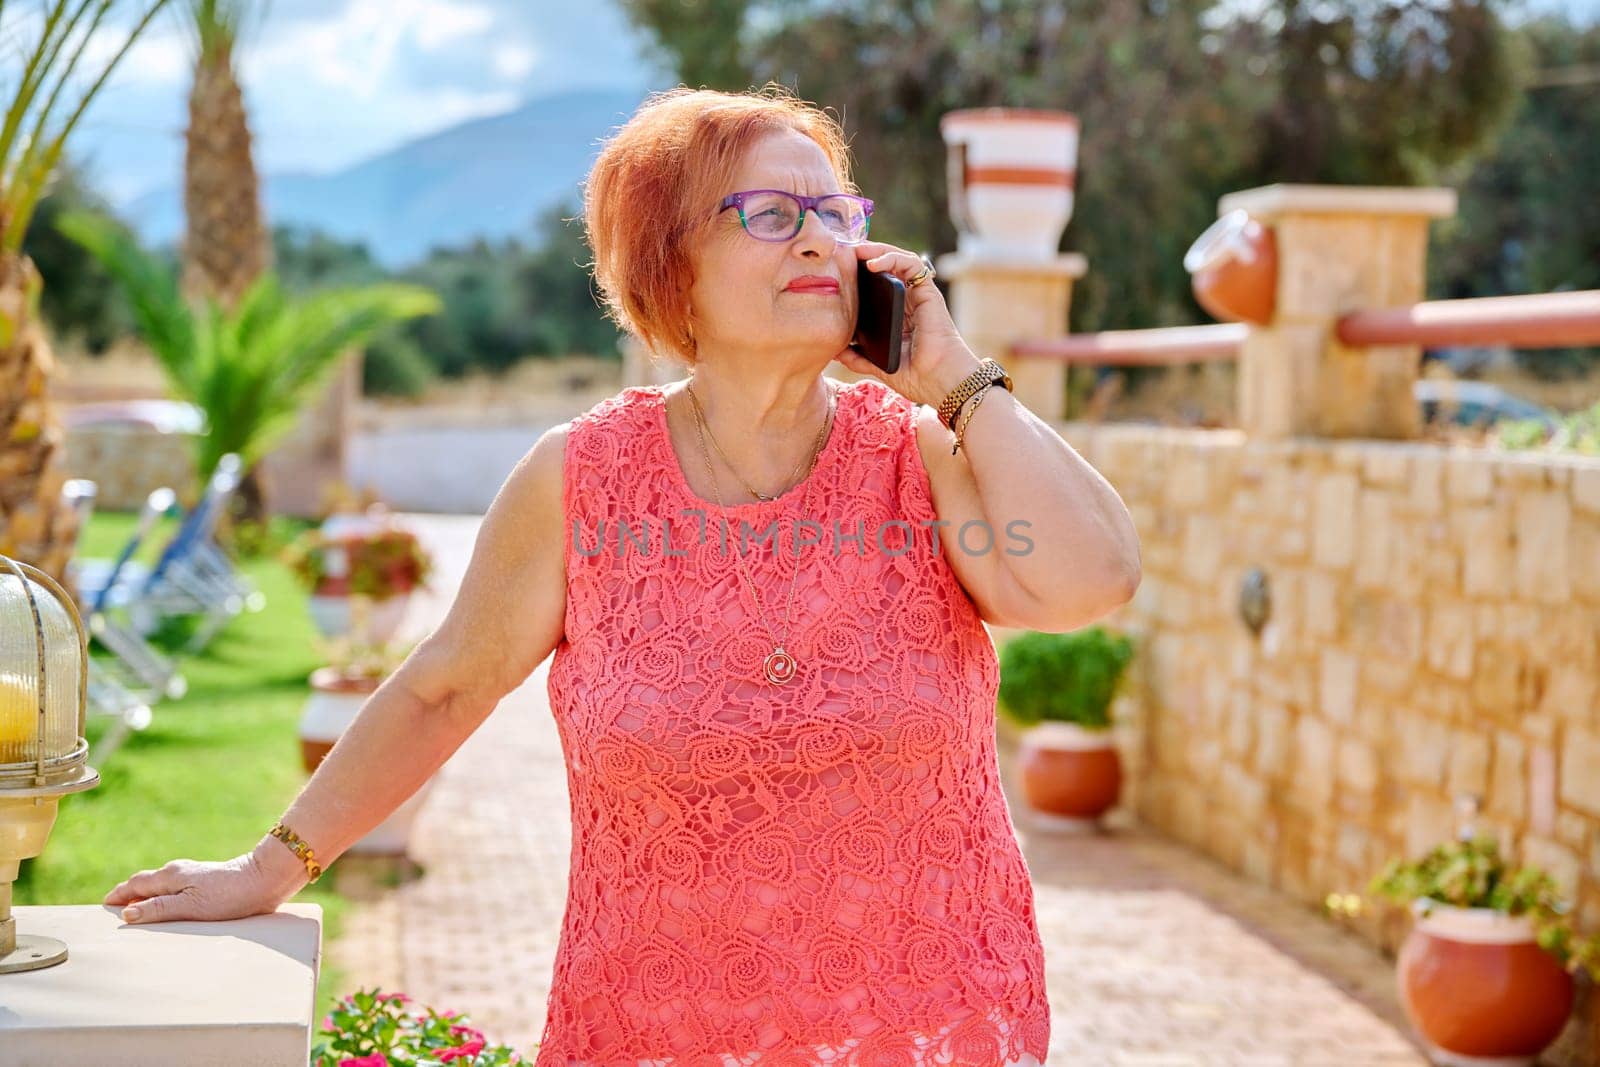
[182,0,272,307]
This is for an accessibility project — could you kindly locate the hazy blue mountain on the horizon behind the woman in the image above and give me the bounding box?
[126,90,646,269]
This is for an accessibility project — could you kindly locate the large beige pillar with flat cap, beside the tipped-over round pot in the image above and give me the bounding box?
[1218,186,1456,438]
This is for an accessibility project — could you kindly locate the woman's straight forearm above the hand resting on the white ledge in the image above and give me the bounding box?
[254,653,493,897]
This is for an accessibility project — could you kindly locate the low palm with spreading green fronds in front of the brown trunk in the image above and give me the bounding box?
[56,211,440,505]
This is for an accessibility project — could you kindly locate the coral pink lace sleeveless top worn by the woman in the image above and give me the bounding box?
[534,379,1050,1067]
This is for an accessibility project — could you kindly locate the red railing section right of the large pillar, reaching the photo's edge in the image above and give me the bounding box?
[1338,290,1600,349]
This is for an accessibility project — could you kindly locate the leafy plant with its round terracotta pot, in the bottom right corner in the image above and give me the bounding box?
[1368,830,1600,1067]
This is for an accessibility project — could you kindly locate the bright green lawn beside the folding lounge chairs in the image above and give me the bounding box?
[16,514,352,1022]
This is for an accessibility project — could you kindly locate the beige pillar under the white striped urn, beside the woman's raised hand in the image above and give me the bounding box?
[934,251,1088,421]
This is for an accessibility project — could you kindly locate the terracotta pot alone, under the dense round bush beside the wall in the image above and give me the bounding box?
[1018,721,1122,830]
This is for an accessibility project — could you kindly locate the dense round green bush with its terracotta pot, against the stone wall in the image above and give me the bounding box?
[1000,625,1133,830]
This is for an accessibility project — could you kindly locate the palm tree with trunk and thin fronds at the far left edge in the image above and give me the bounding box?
[0,0,166,581]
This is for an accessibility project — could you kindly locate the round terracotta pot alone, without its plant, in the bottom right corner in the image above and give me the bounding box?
[1397,901,1573,1067]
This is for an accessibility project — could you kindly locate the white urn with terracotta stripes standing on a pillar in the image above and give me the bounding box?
[939,107,1078,261]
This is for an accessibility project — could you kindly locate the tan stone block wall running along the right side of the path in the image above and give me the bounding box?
[1043,424,1600,1023]
